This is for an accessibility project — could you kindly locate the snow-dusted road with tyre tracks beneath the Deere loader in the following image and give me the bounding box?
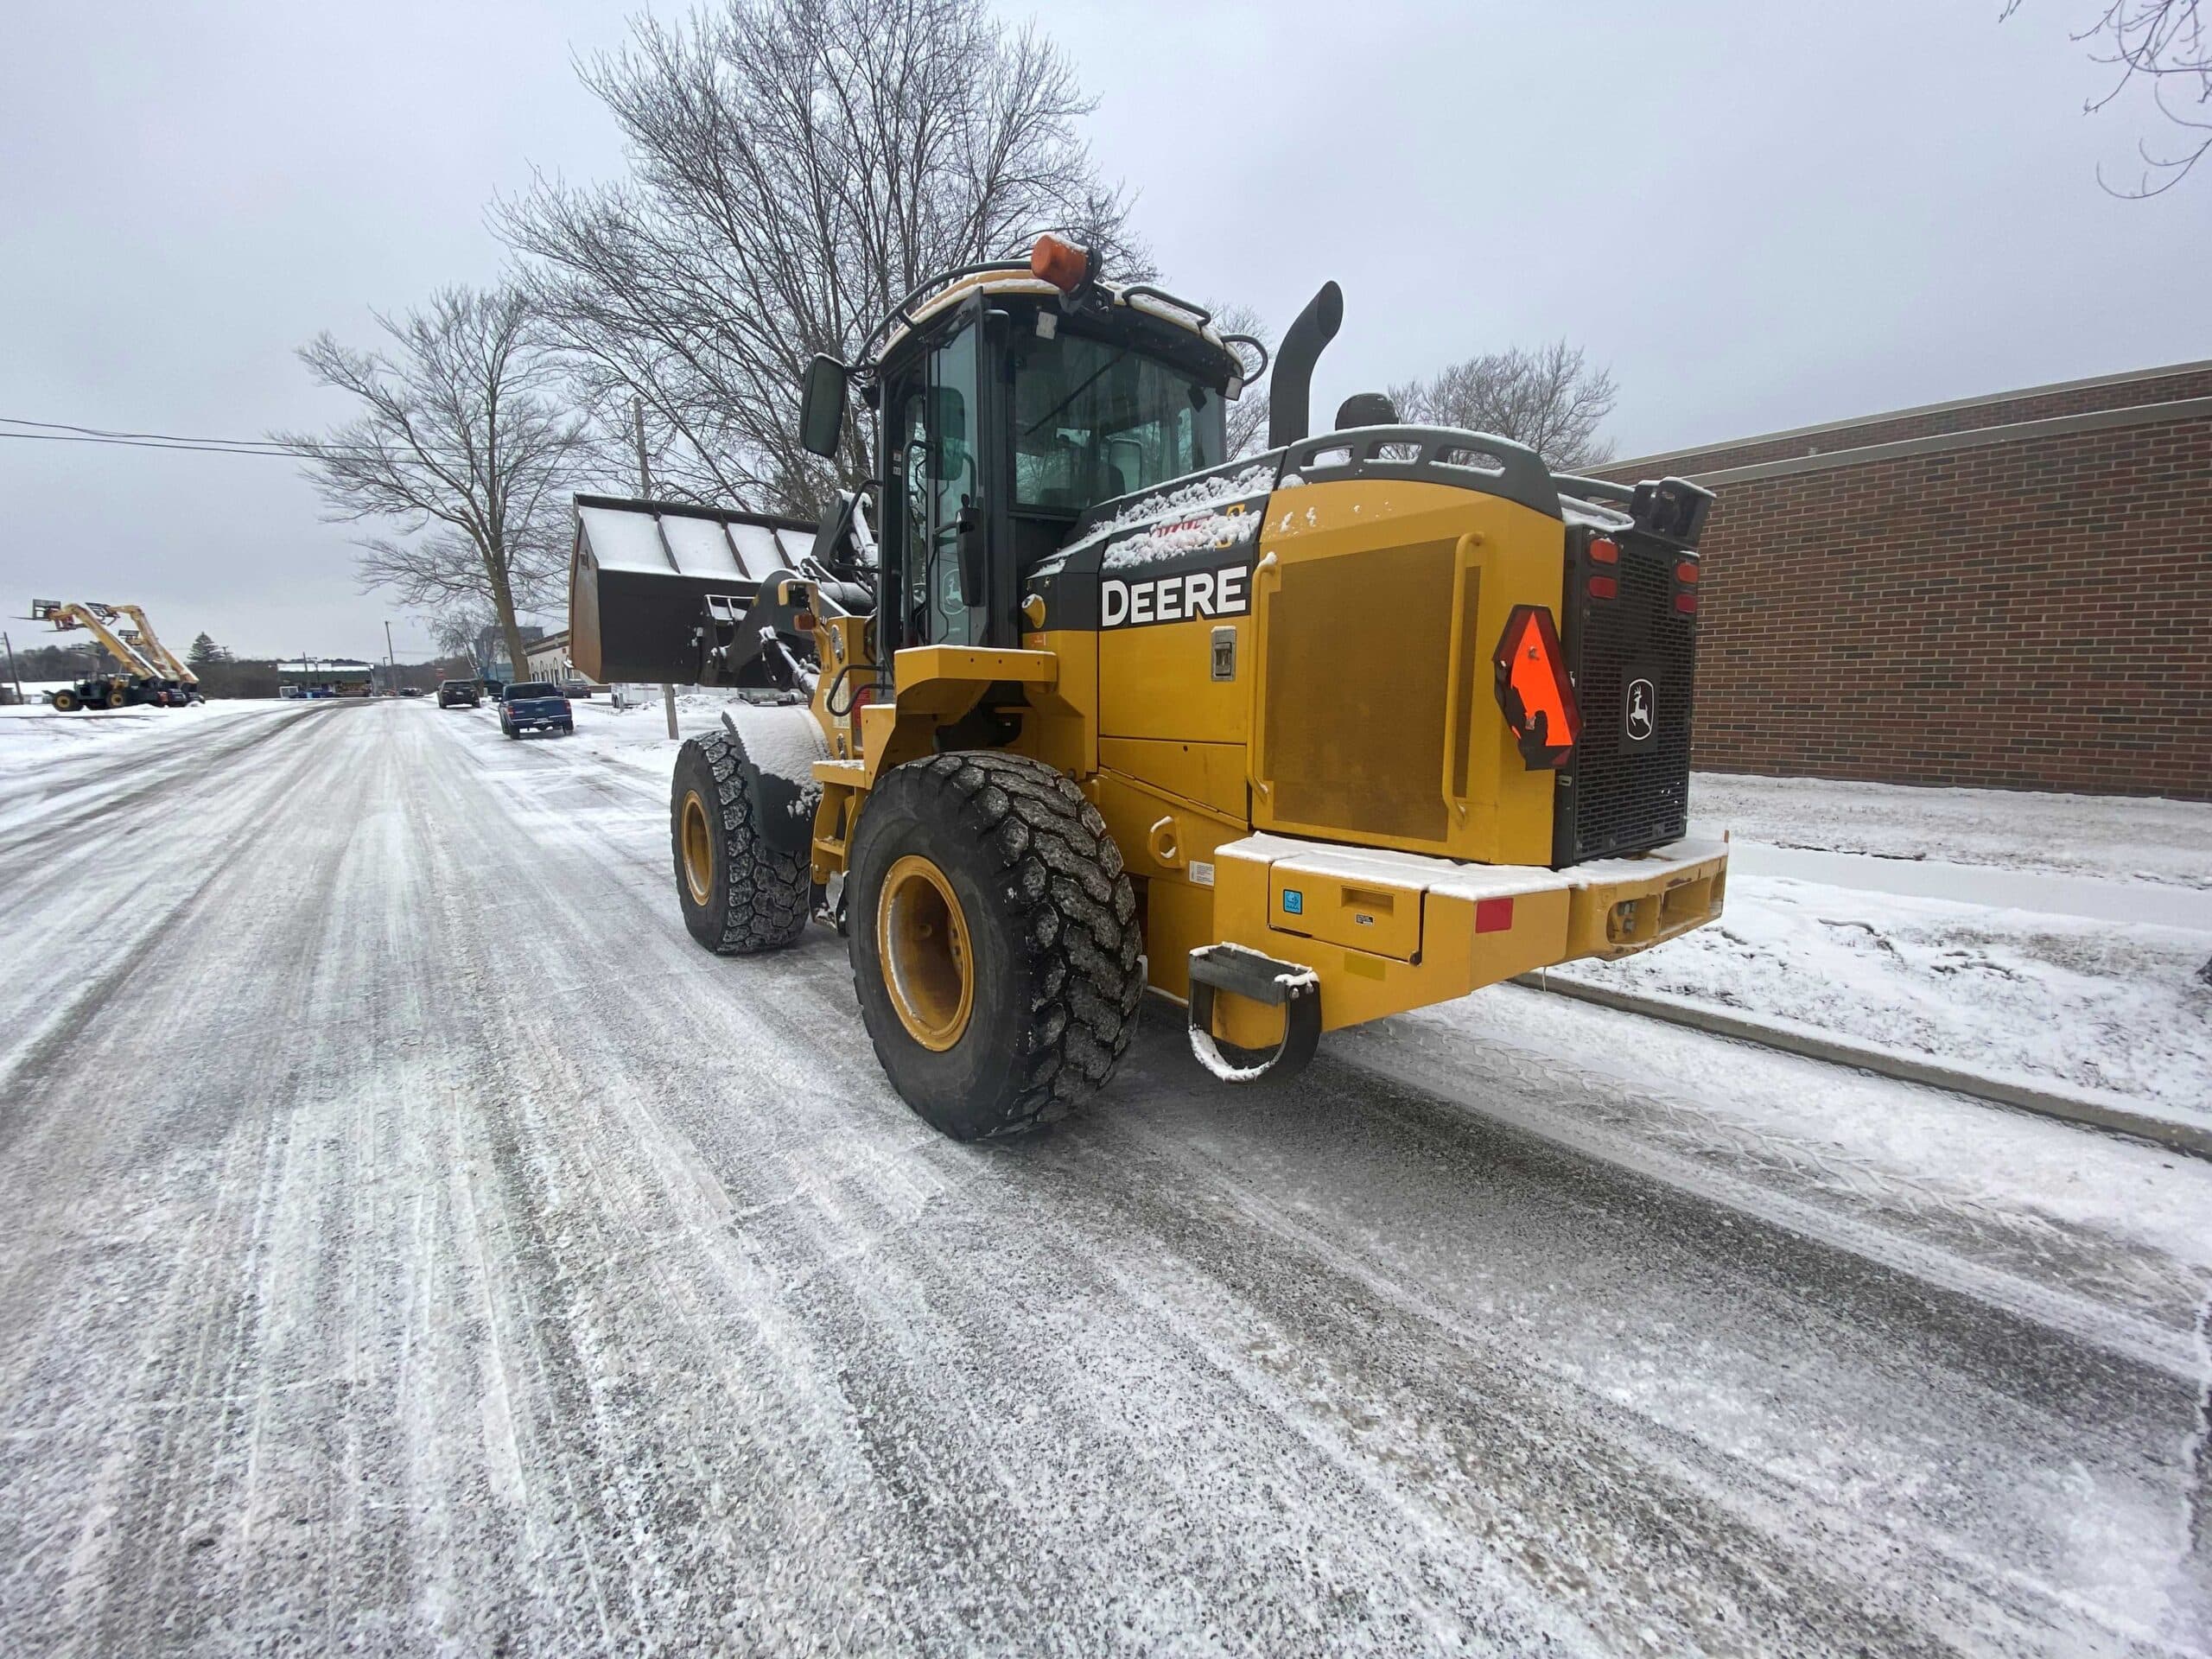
[0,702,2212,1655]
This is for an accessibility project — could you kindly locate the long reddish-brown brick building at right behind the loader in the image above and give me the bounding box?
[1601,363,2212,801]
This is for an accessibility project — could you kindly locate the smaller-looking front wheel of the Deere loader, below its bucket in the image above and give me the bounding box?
[668,725,818,956]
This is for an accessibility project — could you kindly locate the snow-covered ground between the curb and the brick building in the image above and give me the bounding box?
[1555,774,2212,1122]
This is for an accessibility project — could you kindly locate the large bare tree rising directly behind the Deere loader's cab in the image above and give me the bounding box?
[493,0,1150,511]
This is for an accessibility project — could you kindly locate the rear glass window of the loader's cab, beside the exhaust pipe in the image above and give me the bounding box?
[1013,329,1225,511]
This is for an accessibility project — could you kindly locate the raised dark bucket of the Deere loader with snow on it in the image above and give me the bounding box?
[569,495,814,686]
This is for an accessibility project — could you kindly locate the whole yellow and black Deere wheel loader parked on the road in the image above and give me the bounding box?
[570,237,1727,1139]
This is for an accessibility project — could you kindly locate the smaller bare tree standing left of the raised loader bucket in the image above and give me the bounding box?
[276,288,584,672]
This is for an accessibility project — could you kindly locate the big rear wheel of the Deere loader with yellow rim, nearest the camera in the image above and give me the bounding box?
[849,752,1144,1141]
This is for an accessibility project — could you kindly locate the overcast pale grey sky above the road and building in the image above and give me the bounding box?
[0,0,2212,655]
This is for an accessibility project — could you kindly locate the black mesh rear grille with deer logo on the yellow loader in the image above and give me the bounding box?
[1553,533,1697,868]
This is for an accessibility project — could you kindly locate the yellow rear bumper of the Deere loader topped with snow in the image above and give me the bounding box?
[1214,834,1727,1048]
